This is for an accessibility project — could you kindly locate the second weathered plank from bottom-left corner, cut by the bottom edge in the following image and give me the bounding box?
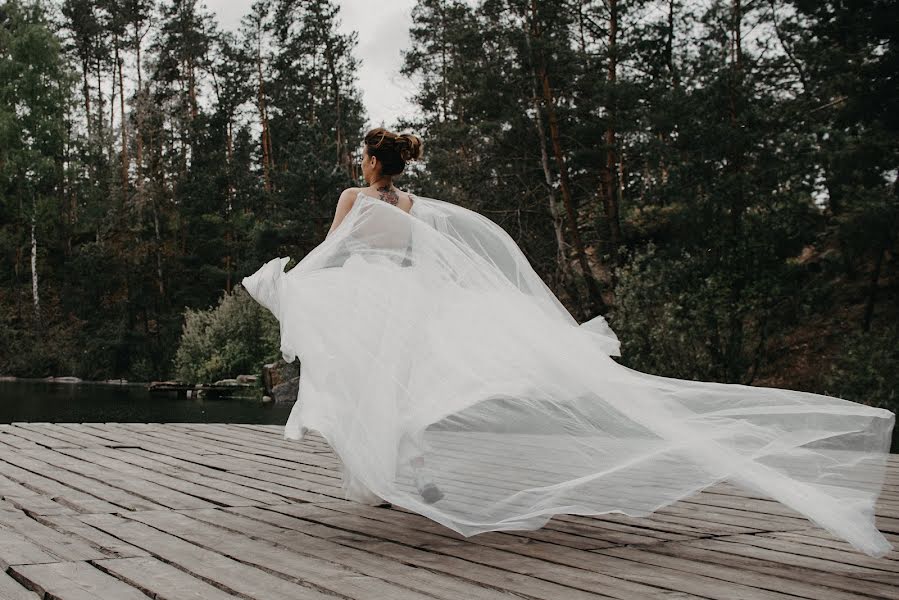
[10,561,149,600]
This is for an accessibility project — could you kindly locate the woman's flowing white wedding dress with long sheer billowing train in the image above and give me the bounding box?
[243,193,895,556]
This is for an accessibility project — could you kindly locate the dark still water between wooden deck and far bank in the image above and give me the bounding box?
[0,380,293,425]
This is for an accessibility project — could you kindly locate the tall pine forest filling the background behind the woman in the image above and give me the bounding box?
[0,0,899,410]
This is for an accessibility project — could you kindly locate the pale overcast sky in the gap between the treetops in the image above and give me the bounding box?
[205,0,415,128]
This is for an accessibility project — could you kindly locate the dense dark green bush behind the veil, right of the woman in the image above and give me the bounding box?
[610,244,804,384]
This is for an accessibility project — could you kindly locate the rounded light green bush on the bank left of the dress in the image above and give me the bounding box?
[174,287,280,383]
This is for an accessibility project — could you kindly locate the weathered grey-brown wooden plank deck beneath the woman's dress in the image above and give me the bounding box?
[0,423,899,600]
